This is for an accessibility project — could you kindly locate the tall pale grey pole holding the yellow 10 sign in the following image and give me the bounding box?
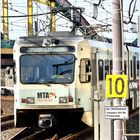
[112,0,123,140]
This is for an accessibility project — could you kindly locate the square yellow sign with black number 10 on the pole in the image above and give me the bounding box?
[106,75,128,98]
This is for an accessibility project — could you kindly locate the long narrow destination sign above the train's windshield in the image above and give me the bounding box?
[20,46,75,53]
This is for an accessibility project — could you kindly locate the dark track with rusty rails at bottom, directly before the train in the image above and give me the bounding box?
[7,128,93,140]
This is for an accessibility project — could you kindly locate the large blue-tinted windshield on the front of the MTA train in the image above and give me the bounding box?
[20,54,75,84]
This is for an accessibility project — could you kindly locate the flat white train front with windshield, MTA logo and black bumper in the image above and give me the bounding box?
[14,35,83,128]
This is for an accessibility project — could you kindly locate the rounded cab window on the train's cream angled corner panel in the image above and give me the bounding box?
[79,58,91,83]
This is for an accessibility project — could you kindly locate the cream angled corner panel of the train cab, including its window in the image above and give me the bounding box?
[76,40,93,126]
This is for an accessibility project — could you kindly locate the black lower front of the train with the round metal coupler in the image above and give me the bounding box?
[16,108,84,129]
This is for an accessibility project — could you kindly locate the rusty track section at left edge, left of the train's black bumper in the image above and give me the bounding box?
[1,115,14,131]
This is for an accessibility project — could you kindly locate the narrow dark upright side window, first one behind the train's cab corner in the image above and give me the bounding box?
[98,59,104,81]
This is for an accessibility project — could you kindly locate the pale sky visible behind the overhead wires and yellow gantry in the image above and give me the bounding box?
[0,0,140,40]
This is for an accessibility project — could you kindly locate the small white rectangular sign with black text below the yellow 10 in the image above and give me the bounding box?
[105,106,129,120]
